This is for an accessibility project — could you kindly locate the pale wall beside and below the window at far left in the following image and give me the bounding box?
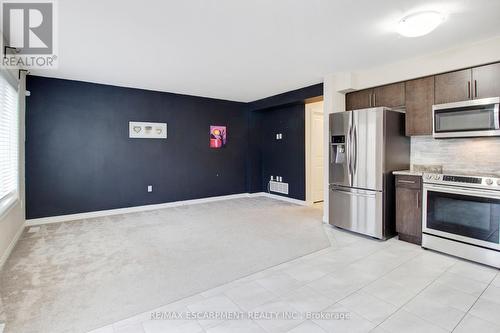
[0,72,26,268]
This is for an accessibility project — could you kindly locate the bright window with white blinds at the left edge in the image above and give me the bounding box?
[0,73,19,208]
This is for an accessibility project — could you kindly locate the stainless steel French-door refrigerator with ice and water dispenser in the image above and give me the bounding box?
[329,107,410,239]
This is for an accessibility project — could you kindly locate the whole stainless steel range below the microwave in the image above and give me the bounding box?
[422,173,500,268]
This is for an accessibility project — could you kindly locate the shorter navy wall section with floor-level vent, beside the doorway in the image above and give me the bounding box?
[247,83,323,200]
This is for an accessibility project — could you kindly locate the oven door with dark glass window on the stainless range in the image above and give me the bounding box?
[422,184,500,251]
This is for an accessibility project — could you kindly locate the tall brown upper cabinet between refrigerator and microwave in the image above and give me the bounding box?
[405,76,434,136]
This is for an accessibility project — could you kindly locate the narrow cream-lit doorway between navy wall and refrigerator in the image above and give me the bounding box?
[305,101,324,205]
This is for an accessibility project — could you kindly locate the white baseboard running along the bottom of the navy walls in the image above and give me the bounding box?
[26,192,307,226]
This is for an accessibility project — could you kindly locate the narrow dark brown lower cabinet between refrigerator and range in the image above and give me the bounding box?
[396,175,422,245]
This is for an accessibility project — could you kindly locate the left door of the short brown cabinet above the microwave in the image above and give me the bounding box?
[435,69,472,104]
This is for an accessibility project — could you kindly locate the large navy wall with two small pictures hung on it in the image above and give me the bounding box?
[26,76,248,219]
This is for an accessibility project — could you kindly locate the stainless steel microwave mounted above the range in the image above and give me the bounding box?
[432,97,500,138]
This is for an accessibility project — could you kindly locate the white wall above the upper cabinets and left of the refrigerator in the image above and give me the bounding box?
[324,36,500,222]
